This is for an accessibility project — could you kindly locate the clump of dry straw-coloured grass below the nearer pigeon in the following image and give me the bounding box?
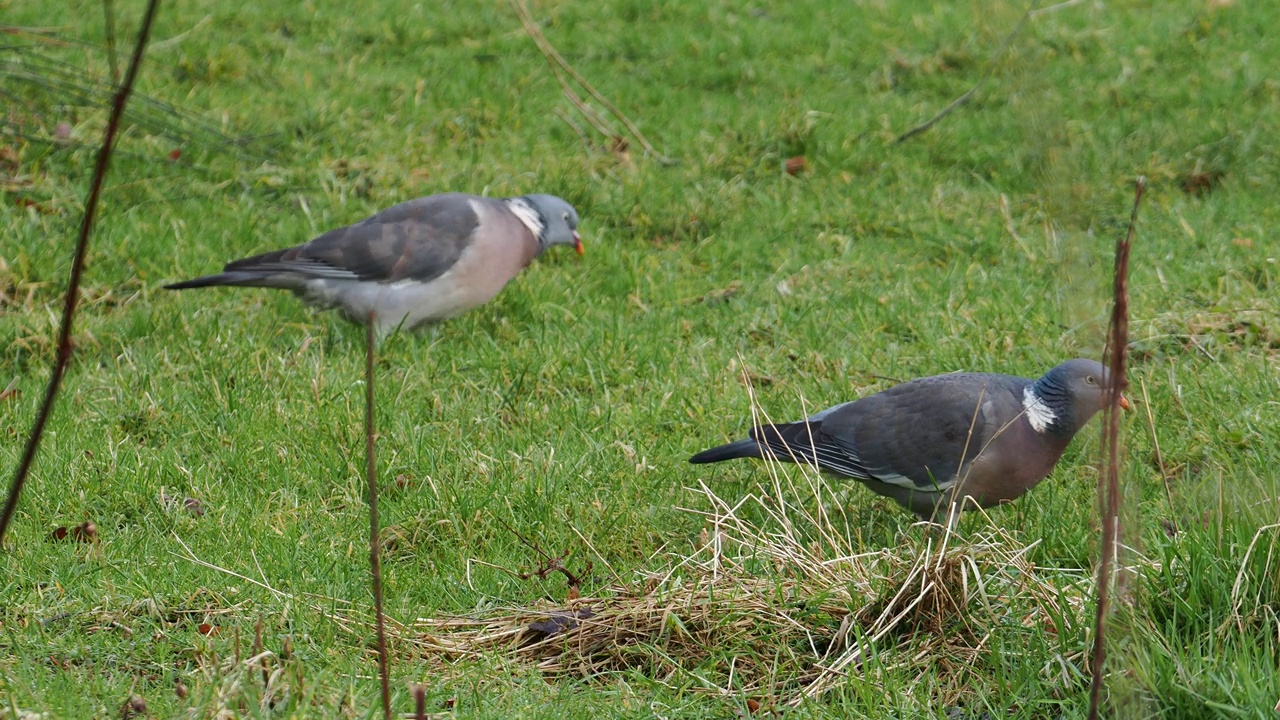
[399,465,1089,705]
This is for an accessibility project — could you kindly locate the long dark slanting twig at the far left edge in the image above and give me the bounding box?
[0,0,160,546]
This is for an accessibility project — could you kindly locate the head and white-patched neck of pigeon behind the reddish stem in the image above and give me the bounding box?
[1023,359,1129,437]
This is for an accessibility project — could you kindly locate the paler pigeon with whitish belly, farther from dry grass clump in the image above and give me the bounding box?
[165,193,582,334]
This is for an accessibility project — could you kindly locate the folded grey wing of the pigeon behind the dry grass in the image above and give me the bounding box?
[823,373,1028,491]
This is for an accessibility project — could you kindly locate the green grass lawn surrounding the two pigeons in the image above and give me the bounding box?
[0,0,1280,720]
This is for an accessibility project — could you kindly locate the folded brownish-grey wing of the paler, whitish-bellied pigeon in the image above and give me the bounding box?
[225,193,488,282]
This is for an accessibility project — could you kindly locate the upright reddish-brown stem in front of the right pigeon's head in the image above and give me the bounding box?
[1089,176,1147,720]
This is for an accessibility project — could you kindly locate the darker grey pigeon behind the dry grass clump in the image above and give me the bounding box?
[689,359,1129,527]
